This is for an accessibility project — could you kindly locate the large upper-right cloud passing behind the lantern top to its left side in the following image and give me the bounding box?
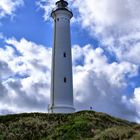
[38,0,140,64]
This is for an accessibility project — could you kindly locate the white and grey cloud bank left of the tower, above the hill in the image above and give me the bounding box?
[0,38,51,113]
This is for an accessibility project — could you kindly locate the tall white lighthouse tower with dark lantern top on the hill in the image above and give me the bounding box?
[48,0,75,113]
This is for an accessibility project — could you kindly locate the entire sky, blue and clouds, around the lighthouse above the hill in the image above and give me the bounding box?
[0,0,140,122]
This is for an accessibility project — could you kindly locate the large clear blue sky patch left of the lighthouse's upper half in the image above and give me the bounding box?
[1,0,52,46]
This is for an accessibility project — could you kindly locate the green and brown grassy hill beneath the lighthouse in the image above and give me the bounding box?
[0,111,140,140]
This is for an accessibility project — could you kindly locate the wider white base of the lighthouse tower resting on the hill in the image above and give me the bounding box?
[48,105,75,114]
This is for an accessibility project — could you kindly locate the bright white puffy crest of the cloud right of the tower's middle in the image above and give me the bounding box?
[73,45,138,87]
